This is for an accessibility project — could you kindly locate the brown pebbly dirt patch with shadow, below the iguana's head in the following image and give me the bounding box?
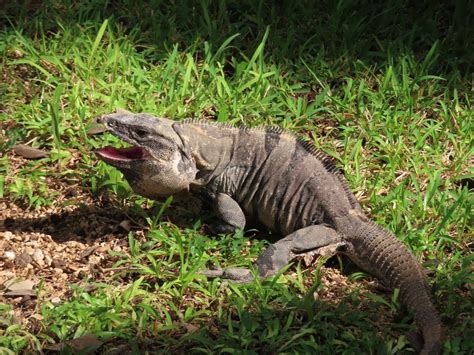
[0,163,137,325]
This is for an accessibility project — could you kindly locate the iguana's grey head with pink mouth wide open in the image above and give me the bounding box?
[96,111,197,198]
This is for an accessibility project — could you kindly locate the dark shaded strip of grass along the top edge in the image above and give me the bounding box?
[0,0,474,77]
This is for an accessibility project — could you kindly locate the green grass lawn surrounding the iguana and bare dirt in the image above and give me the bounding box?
[0,0,474,354]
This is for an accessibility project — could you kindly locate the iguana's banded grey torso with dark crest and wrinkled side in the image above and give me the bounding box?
[177,121,360,236]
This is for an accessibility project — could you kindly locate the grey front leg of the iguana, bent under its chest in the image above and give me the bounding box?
[208,193,245,234]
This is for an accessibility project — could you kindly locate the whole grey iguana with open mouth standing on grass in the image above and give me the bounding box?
[96,111,443,354]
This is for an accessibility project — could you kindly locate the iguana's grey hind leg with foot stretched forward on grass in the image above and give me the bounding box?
[204,225,345,282]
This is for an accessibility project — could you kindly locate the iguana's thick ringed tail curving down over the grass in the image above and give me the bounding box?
[347,221,443,355]
